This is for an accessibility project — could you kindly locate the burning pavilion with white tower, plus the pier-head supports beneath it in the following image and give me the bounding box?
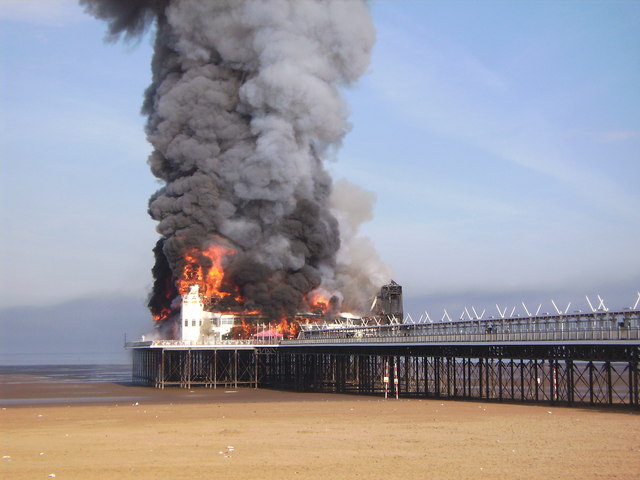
[126,281,402,388]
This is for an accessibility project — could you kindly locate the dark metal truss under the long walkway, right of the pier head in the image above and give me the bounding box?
[258,342,640,408]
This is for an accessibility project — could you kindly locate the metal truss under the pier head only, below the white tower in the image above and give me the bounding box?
[129,342,258,388]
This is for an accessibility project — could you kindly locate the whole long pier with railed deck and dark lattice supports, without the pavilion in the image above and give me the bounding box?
[128,300,640,409]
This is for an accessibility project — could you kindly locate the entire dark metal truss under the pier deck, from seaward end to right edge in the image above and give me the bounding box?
[130,342,640,408]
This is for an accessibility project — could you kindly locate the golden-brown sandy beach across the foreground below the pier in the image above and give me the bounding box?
[0,382,640,480]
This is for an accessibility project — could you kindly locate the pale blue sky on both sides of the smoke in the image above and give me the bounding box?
[0,0,640,321]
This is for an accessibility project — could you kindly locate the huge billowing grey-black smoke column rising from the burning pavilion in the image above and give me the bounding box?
[80,0,389,330]
